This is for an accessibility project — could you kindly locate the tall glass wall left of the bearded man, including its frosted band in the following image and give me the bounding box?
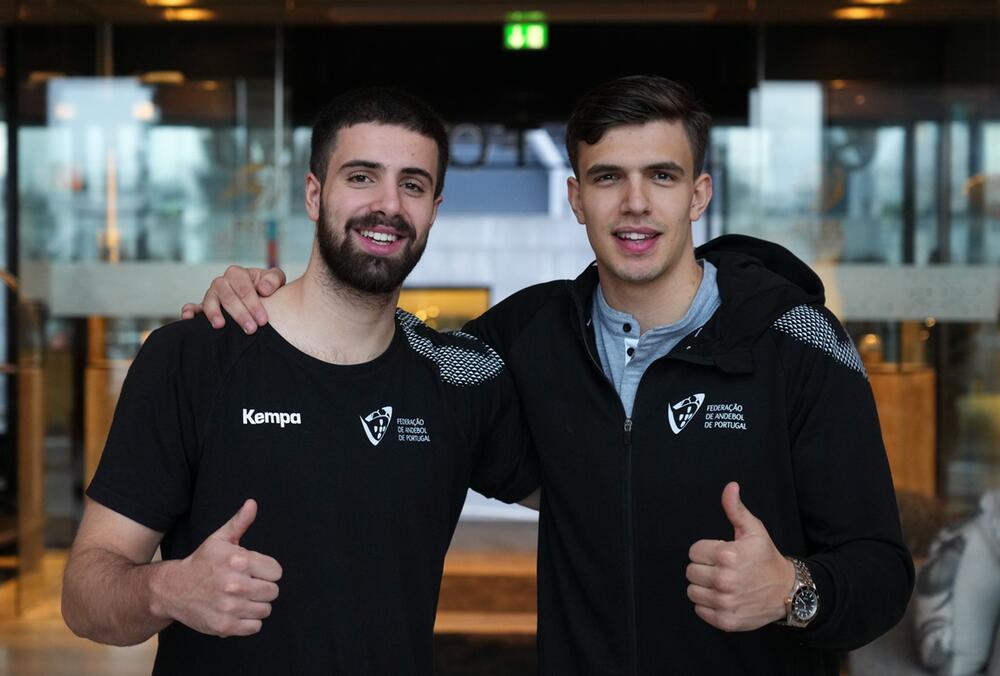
[17,25,289,546]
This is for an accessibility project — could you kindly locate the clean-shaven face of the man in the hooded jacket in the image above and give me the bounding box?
[568,121,712,284]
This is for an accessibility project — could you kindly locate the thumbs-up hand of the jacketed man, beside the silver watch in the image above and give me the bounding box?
[687,482,795,631]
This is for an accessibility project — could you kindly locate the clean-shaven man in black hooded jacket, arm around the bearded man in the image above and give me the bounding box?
[186,77,913,676]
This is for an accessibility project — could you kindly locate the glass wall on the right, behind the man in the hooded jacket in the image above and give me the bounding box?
[712,81,1000,511]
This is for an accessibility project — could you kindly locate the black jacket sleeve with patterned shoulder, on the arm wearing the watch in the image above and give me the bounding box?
[774,306,914,651]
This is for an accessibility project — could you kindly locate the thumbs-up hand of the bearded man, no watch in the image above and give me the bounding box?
[152,500,281,636]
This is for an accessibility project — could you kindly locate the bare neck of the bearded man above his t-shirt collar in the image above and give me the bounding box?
[263,247,399,365]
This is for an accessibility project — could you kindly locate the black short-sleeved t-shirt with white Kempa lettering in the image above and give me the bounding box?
[87,311,538,676]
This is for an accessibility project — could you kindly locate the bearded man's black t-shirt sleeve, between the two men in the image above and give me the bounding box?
[470,369,539,502]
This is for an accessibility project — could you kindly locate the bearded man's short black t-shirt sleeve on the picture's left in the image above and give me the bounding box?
[87,320,215,532]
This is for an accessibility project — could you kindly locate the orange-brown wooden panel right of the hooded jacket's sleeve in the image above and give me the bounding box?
[869,367,937,496]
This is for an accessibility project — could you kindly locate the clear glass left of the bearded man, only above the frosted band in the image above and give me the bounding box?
[20,78,284,263]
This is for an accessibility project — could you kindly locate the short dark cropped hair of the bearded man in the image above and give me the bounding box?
[309,87,448,197]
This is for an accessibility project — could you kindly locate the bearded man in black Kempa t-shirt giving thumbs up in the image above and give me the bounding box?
[63,89,538,675]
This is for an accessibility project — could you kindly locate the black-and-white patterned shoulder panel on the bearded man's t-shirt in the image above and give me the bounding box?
[396,309,504,386]
